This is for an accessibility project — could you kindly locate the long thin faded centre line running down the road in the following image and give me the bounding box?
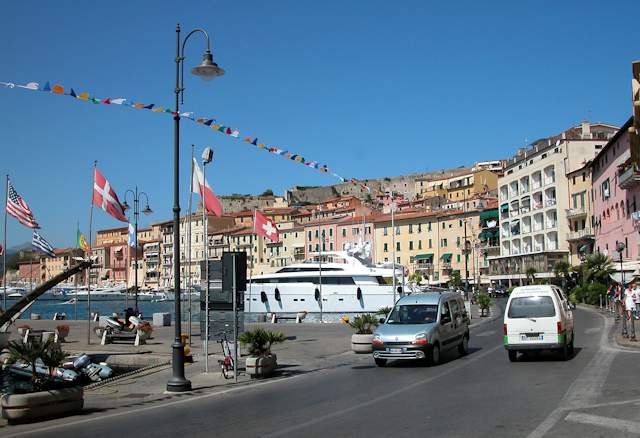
[262,345,503,438]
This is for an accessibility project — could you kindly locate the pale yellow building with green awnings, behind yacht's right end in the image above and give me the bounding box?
[373,210,485,285]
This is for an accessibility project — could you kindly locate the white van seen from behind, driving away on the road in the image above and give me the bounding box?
[504,284,574,362]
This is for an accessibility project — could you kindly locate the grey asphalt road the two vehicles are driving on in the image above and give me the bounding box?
[5,309,640,438]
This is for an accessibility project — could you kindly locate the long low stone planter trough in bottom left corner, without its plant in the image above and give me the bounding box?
[0,386,84,423]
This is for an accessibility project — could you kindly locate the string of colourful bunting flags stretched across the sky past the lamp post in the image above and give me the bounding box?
[0,81,371,192]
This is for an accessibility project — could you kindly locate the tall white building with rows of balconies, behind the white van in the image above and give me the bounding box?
[490,122,617,285]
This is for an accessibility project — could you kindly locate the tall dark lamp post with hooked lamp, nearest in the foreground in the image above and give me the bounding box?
[167,24,224,392]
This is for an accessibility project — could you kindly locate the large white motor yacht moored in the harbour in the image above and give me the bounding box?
[244,251,403,313]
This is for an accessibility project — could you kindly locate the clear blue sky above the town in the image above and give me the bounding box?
[0,0,640,247]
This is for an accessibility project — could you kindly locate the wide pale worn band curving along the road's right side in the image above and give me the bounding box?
[527,312,618,438]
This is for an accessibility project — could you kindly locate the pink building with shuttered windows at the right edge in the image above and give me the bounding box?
[592,117,640,261]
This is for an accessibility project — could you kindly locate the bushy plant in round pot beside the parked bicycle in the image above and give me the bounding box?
[238,328,285,377]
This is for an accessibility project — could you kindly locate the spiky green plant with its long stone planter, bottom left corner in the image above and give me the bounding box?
[0,339,84,423]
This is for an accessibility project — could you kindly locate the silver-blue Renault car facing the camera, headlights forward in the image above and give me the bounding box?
[372,292,469,367]
